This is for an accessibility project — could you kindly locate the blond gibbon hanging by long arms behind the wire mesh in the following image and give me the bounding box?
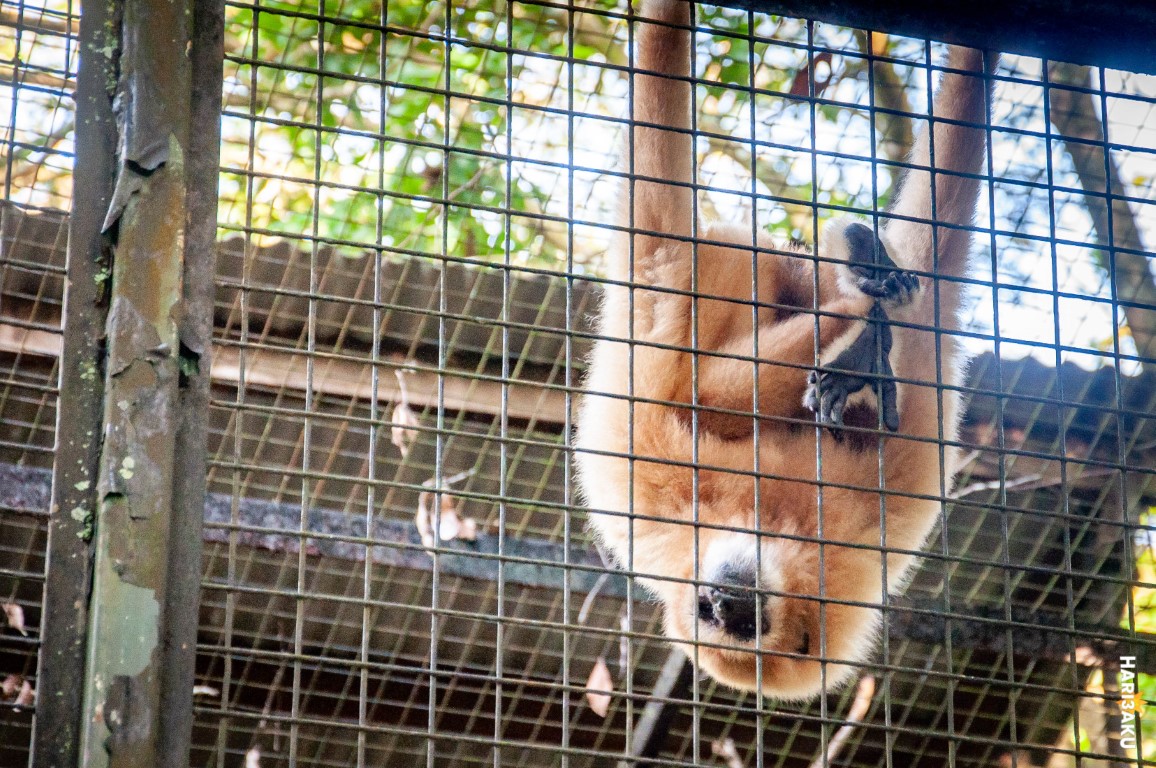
[576,0,995,700]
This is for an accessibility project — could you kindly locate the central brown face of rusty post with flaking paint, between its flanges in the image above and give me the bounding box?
[79,0,191,768]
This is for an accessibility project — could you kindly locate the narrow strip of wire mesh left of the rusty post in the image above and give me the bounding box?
[0,0,76,766]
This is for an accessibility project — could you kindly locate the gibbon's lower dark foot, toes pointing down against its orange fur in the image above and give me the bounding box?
[803,303,899,440]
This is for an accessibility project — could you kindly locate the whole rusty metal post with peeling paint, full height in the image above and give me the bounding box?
[34,0,223,768]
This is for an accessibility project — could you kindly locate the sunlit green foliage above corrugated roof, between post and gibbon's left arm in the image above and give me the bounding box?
[221,0,633,265]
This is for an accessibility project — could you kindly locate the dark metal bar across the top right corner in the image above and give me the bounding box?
[720,0,1156,74]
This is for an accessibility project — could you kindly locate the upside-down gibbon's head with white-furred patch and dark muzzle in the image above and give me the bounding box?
[655,508,882,700]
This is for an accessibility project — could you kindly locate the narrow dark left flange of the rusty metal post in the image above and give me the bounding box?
[32,2,119,768]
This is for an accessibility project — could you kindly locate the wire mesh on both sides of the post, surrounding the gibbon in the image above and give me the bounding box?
[0,0,1156,768]
